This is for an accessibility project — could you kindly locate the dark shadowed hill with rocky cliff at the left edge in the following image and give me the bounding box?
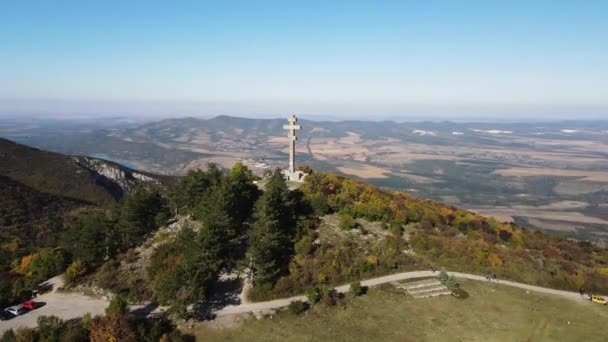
[0,139,171,272]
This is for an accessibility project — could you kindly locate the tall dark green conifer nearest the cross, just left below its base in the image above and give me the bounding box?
[249,170,295,286]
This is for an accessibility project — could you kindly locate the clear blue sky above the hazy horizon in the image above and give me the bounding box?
[0,0,608,118]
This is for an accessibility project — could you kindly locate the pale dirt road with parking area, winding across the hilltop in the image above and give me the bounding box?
[0,271,582,335]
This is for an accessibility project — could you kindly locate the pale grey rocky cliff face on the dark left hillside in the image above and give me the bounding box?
[72,156,160,198]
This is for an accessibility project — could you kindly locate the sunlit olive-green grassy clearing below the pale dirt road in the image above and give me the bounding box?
[185,281,608,341]
